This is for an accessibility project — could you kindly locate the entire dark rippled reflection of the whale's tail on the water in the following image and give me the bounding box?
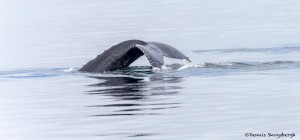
[87,74,182,117]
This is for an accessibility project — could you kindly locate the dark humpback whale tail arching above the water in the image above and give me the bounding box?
[79,40,191,73]
